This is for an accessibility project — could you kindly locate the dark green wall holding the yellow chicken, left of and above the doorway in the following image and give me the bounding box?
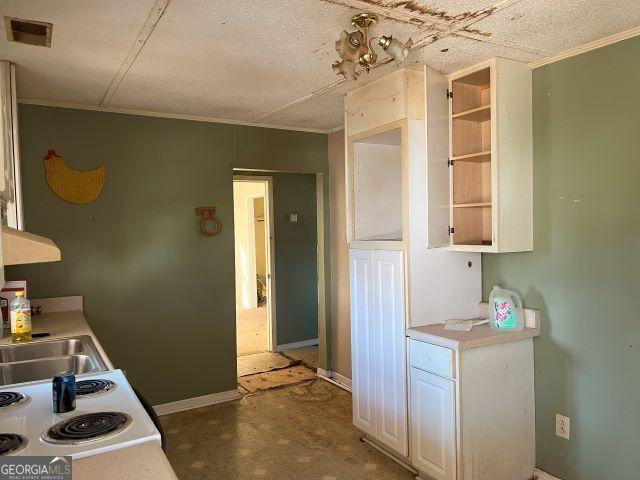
[6,105,328,404]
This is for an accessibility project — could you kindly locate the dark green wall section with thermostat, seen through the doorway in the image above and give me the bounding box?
[242,172,318,345]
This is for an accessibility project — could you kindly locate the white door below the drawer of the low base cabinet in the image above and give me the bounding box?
[410,367,456,480]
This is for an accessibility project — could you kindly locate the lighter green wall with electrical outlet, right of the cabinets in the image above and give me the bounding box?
[482,38,640,480]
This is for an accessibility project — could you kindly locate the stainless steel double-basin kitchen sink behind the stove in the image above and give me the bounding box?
[0,335,107,385]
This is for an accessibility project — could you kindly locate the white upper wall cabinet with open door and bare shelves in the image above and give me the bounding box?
[425,58,533,252]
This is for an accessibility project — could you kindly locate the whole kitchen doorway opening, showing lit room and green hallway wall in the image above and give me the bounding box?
[233,172,322,392]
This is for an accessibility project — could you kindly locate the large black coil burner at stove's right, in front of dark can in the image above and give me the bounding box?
[42,412,131,444]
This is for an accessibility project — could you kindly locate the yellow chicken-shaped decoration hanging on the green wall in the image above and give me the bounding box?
[44,150,105,205]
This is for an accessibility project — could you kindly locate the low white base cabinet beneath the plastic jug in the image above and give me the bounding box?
[408,334,539,480]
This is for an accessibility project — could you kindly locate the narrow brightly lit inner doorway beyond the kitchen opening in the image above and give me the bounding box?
[233,177,276,357]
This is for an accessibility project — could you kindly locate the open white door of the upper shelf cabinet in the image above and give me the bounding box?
[424,66,451,248]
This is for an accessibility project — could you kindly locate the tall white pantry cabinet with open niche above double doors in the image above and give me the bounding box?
[345,69,481,462]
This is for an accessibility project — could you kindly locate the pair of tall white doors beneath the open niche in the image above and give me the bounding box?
[349,249,409,457]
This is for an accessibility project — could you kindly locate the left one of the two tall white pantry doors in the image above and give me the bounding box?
[349,250,376,437]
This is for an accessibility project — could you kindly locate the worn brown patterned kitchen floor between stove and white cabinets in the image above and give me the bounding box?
[160,380,413,480]
